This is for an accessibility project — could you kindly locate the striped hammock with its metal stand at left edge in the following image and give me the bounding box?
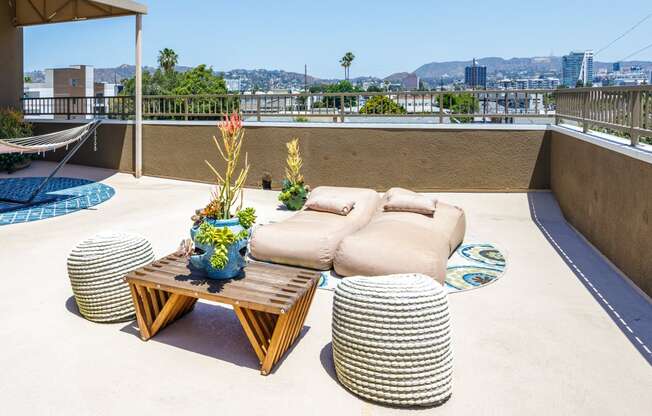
[0,120,102,207]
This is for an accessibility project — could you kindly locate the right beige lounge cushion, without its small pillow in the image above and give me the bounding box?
[333,190,466,284]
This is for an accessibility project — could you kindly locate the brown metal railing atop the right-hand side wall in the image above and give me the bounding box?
[555,85,652,146]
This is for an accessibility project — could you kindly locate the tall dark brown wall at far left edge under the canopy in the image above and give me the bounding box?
[0,1,23,108]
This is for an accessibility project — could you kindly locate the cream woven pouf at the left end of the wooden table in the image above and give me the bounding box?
[68,233,154,322]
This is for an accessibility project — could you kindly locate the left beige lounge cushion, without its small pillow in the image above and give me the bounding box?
[250,186,380,270]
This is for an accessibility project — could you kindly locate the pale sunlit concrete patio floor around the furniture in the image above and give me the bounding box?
[0,162,652,415]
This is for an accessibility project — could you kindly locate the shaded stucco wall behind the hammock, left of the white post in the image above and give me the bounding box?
[32,122,134,172]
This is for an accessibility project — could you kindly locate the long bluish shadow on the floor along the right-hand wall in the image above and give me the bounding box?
[528,192,652,365]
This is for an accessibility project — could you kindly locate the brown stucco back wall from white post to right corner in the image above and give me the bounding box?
[143,124,549,191]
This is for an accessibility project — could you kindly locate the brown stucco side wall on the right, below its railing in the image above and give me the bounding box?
[550,131,652,296]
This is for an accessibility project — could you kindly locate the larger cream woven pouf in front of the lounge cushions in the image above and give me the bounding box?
[333,274,453,406]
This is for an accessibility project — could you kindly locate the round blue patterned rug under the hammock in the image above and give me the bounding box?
[0,177,115,225]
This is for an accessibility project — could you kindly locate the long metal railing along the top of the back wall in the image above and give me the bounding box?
[23,90,554,123]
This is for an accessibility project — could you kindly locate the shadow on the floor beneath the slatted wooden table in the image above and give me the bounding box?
[120,300,310,374]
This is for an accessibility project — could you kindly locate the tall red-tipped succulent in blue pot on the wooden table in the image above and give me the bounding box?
[190,113,256,279]
